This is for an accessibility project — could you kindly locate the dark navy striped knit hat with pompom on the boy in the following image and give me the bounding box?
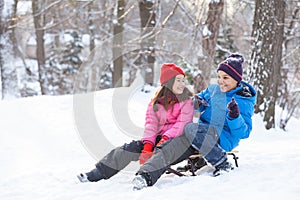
[217,54,244,83]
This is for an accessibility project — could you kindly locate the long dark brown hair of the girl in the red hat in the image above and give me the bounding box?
[152,76,193,112]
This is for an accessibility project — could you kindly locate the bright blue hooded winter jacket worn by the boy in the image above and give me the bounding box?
[197,81,256,151]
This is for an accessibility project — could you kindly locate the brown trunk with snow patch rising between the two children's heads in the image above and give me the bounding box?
[199,0,224,84]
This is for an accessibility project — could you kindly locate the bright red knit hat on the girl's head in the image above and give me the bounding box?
[160,63,185,85]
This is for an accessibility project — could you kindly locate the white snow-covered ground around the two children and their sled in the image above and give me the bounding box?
[0,88,300,200]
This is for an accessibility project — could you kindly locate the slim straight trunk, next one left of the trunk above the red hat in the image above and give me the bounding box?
[112,0,125,87]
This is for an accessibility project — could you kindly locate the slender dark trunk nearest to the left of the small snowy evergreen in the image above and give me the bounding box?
[32,0,47,95]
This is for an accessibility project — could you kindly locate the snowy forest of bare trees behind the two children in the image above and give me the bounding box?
[0,0,300,129]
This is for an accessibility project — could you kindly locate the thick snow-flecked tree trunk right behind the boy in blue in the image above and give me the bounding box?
[250,0,285,129]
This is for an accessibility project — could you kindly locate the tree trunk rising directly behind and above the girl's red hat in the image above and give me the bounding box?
[139,0,156,85]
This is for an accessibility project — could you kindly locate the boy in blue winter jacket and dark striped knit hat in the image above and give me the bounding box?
[133,54,256,189]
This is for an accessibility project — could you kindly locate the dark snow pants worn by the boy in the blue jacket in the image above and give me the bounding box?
[137,123,227,186]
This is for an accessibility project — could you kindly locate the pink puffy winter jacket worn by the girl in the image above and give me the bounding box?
[142,99,194,146]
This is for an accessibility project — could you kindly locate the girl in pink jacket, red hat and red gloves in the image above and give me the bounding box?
[77,63,194,182]
